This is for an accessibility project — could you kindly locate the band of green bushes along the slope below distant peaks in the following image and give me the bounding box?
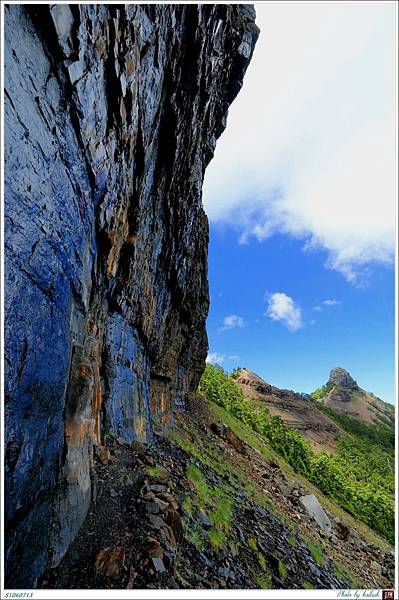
[199,365,395,543]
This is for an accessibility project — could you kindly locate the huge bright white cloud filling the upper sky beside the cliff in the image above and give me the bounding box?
[204,3,395,281]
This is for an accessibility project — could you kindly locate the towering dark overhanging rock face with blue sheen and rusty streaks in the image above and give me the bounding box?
[5,4,258,588]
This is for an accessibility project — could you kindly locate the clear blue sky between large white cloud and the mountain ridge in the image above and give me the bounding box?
[207,226,394,402]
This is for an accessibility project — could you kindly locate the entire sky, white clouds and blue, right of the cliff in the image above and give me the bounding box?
[204,3,395,402]
